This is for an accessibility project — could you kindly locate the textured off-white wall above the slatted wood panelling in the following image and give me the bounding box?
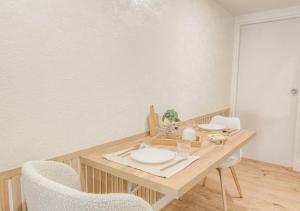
[0,0,233,170]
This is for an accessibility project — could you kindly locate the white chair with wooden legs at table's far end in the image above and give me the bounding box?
[203,116,243,211]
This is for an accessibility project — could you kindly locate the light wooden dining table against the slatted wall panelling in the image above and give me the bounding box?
[80,129,255,210]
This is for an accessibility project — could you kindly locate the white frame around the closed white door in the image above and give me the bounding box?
[230,6,300,172]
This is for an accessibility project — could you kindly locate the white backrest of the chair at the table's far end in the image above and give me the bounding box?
[210,115,242,160]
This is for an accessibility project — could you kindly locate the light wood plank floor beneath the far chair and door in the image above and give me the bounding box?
[163,160,300,211]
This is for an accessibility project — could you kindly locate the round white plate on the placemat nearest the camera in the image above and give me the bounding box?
[130,147,175,164]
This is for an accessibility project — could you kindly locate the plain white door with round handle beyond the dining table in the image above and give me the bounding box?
[236,18,300,167]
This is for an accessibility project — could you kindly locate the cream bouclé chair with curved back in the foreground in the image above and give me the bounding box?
[22,161,153,211]
